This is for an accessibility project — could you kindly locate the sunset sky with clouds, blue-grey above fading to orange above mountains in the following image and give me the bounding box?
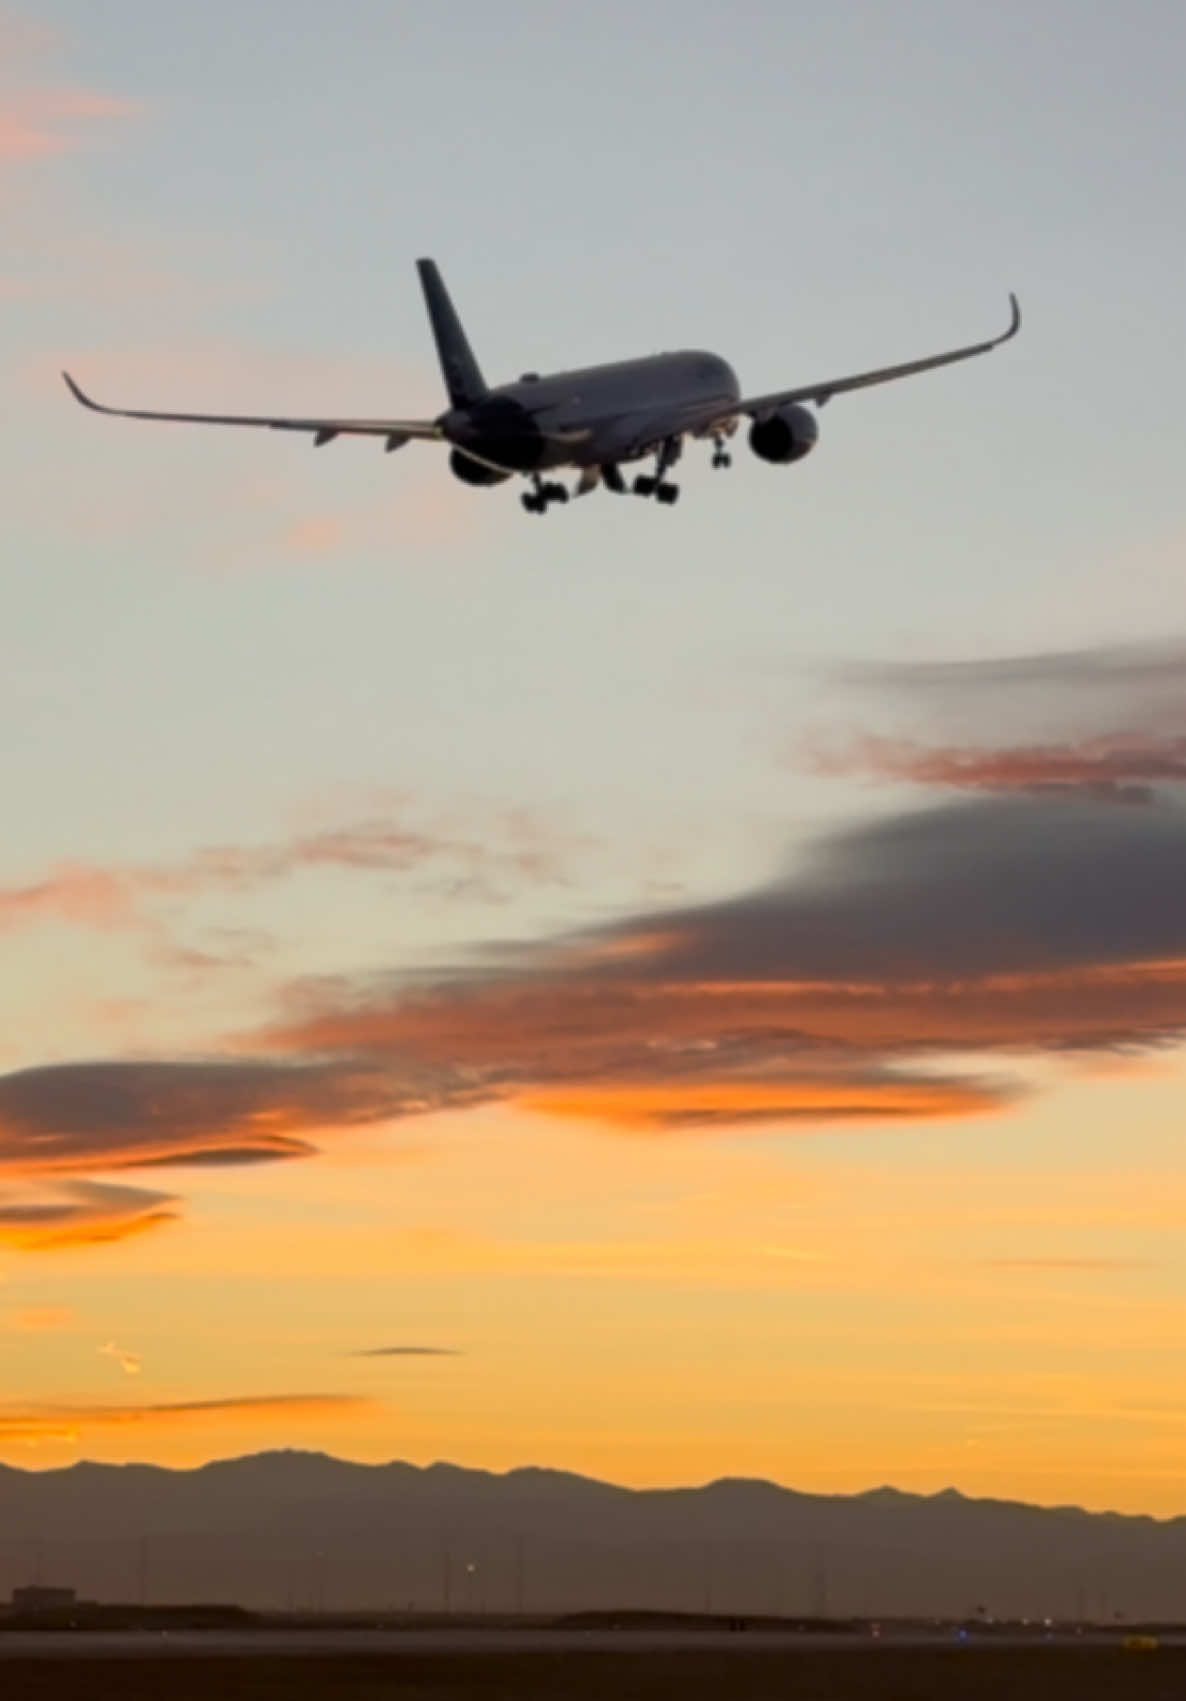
[0,0,1186,1516]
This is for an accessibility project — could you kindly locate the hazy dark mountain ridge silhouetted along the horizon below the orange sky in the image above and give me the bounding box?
[0,1451,1186,1621]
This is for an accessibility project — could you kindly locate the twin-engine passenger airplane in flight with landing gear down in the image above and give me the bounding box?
[61,259,1021,514]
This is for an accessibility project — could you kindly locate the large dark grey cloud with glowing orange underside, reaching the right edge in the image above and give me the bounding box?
[250,782,1186,1129]
